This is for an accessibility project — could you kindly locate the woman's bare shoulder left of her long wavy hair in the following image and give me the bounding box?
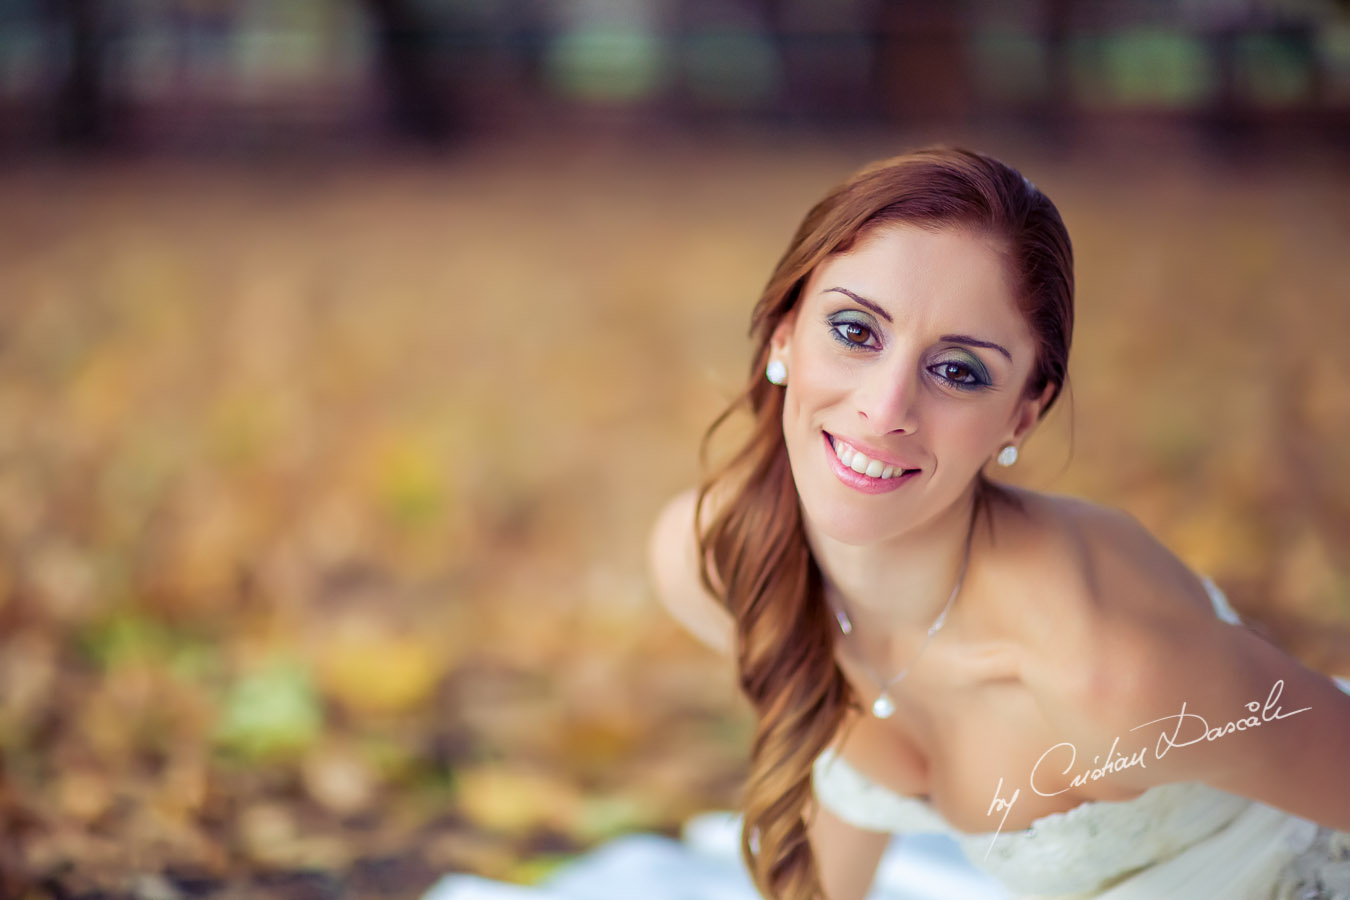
[647,487,734,653]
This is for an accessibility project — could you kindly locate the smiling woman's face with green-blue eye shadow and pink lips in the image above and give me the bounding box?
[772,224,1050,544]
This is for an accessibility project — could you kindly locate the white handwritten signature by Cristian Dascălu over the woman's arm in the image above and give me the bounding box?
[984,679,1312,860]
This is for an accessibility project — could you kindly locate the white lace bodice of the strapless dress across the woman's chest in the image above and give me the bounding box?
[813,578,1350,900]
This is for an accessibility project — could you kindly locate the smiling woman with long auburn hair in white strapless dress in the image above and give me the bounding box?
[649,148,1350,900]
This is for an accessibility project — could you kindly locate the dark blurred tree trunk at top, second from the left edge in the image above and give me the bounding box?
[365,0,455,144]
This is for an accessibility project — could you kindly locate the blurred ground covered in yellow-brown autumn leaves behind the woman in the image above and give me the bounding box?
[0,128,1350,900]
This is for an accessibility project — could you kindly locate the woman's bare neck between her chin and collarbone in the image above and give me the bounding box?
[803,486,975,637]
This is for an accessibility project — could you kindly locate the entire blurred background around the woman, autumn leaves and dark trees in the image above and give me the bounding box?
[0,0,1350,900]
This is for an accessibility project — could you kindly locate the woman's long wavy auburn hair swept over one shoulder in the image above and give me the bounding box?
[694,146,1073,900]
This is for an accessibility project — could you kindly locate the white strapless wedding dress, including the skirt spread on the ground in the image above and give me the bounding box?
[423,579,1350,900]
